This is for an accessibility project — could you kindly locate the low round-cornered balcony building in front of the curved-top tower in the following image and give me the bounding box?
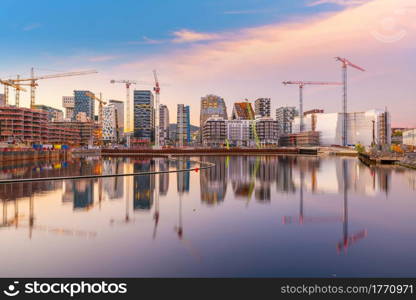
[202,116,227,147]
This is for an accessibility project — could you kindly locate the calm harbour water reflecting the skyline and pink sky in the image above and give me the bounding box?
[0,156,416,277]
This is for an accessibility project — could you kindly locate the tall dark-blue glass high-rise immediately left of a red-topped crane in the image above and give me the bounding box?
[134,90,155,142]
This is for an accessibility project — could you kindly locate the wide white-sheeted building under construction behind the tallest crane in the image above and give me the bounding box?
[293,109,391,146]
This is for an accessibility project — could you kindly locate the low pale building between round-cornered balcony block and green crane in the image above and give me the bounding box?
[227,120,254,147]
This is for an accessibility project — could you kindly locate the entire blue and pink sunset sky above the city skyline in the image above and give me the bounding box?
[0,0,416,127]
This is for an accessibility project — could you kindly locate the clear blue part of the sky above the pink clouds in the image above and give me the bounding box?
[0,0,340,71]
